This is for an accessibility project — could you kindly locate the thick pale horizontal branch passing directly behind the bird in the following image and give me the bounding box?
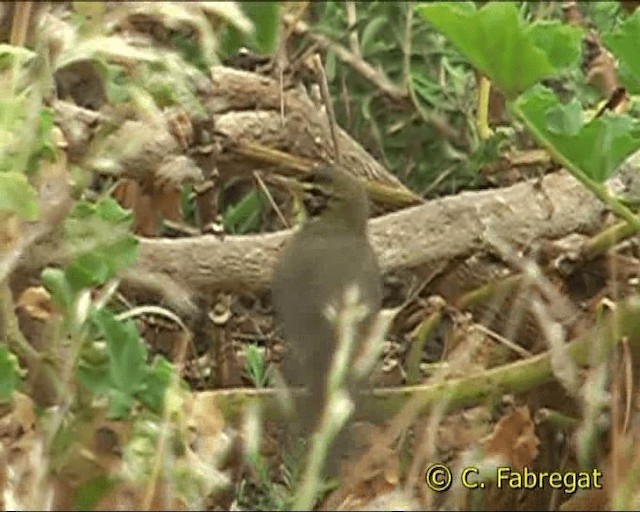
[120,174,604,300]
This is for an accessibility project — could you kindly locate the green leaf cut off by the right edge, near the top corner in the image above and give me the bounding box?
[602,9,640,94]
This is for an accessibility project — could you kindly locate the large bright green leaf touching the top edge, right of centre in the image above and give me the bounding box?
[417,2,556,98]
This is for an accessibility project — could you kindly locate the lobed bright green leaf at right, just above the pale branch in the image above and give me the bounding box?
[515,86,640,182]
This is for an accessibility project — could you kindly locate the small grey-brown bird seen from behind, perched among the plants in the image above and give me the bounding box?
[272,167,382,472]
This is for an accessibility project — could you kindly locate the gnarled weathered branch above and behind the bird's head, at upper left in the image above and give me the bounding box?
[54,66,420,208]
